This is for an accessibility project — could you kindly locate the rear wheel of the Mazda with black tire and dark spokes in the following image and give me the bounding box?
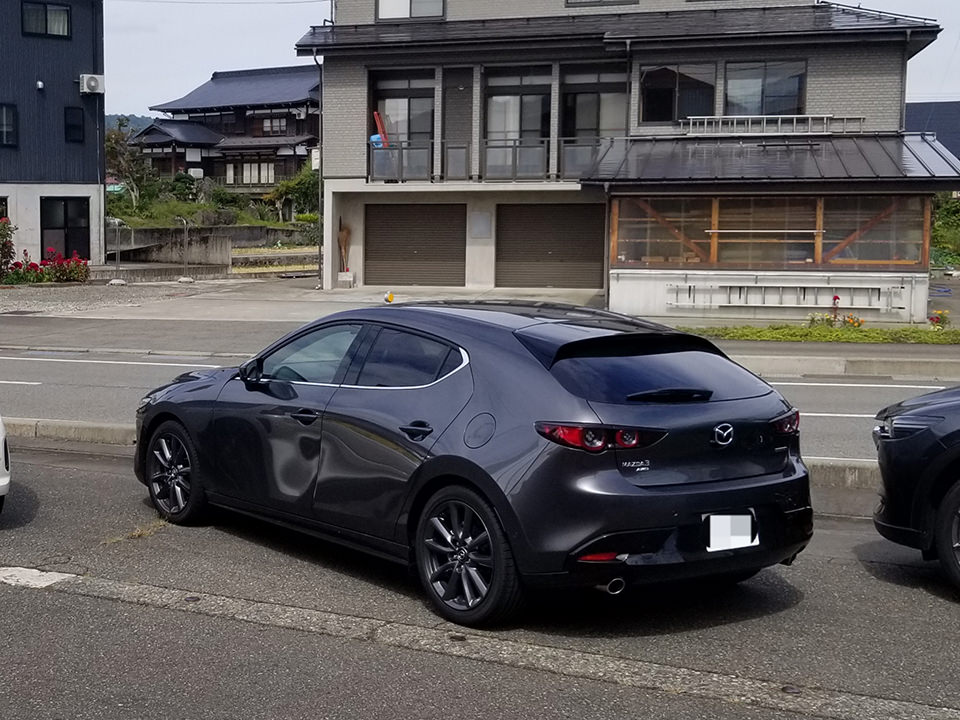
[414,486,523,626]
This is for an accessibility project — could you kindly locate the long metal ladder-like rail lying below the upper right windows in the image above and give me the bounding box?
[680,115,866,135]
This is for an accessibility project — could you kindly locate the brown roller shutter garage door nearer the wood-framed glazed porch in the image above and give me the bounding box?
[496,205,606,288]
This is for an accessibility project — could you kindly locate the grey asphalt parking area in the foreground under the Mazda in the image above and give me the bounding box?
[0,451,960,720]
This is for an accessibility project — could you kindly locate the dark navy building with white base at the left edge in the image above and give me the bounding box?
[0,0,104,262]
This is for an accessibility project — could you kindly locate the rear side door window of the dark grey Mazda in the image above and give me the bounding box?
[357,328,460,387]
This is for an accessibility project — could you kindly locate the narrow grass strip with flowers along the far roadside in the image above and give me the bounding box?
[678,325,960,345]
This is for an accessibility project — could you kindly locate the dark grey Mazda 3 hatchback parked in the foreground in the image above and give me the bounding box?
[136,302,813,625]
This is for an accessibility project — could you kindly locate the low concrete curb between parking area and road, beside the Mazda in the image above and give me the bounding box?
[3,418,880,517]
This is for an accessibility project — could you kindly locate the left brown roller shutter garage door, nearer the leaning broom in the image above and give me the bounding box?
[363,205,467,286]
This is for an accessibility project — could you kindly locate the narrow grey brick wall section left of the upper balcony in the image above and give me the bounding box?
[323,58,370,178]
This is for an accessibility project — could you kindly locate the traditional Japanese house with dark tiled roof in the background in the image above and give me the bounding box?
[133,64,320,194]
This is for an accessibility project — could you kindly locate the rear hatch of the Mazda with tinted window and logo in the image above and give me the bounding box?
[550,333,796,486]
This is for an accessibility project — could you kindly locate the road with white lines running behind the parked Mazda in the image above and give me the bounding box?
[0,349,942,459]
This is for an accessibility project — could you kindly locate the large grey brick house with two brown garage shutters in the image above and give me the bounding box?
[297,0,960,321]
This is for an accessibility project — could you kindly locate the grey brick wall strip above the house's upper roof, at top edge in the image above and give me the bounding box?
[334,0,814,25]
